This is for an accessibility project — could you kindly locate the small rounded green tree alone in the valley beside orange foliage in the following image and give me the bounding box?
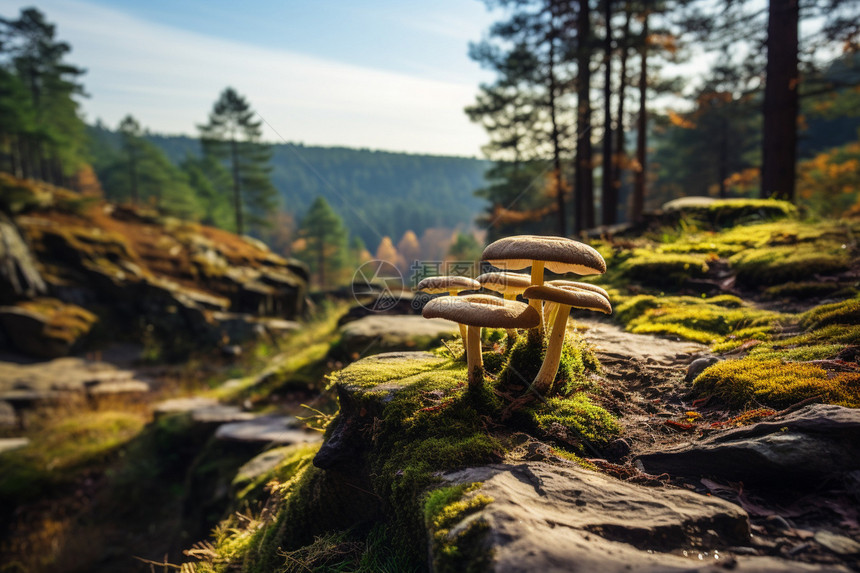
[295,197,347,287]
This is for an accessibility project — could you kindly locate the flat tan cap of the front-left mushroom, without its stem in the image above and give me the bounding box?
[421,294,540,328]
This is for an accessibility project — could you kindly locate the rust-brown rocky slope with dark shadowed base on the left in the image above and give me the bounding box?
[0,176,308,357]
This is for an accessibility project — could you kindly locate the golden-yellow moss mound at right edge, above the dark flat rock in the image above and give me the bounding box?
[693,356,860,408]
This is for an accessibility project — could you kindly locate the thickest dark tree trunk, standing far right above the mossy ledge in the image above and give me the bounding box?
[761,0,800,201]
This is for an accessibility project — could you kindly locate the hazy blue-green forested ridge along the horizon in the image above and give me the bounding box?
[90,127,490,250]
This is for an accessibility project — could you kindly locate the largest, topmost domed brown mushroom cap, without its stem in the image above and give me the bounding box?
[481,235,606,275]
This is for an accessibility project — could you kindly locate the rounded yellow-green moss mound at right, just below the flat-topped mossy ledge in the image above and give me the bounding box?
[729,244,851,285]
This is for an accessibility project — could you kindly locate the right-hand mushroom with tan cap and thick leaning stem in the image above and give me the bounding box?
[523,285,612,394]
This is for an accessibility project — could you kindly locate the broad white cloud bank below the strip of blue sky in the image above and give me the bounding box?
[2,0,486,155]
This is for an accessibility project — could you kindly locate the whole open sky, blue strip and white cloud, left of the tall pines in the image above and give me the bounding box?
[0,0,495,156]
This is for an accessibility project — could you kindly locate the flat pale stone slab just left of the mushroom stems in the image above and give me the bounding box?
[341,314,459,356]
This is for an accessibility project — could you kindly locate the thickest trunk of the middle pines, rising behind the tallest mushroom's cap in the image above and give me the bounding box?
[575,0,594,233]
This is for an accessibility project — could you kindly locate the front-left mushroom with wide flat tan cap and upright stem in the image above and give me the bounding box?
[421,294,540,391]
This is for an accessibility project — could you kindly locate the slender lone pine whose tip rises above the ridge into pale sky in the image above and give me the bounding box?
[197,87,276,235]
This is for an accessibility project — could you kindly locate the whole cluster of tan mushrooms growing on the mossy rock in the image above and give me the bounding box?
[418,235,612,394]
